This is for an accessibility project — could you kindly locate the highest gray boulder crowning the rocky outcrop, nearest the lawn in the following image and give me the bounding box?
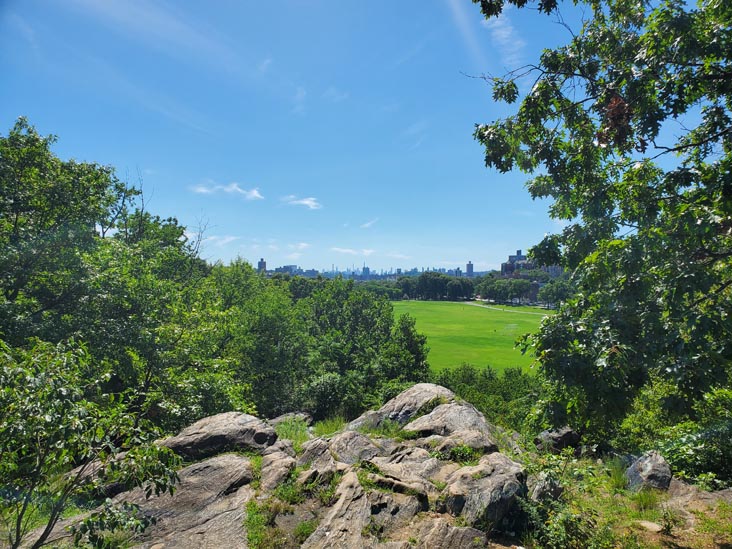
[346,383,455,431]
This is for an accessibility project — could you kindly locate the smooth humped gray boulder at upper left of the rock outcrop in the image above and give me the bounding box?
[160,412,277,460]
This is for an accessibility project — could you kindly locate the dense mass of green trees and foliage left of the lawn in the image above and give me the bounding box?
[0,119,429,546]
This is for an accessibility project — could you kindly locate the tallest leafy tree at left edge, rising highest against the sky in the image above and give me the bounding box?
[0,118,136,343]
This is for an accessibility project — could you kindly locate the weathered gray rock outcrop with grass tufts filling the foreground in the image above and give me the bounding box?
[33,383,728,549]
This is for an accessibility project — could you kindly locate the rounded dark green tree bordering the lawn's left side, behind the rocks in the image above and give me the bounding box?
[297,278,429,417]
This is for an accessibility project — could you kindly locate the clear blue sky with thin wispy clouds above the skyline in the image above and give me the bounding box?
[0,0,569,270]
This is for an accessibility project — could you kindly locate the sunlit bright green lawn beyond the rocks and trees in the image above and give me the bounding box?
[392,301,547,371]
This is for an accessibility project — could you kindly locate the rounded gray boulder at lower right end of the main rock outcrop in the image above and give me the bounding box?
[445,453,526,529]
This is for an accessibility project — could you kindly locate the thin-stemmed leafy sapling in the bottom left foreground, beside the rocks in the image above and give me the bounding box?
[0,342,179,548]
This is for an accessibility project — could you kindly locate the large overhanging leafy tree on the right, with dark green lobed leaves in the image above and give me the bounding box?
[474,0,732,436]
